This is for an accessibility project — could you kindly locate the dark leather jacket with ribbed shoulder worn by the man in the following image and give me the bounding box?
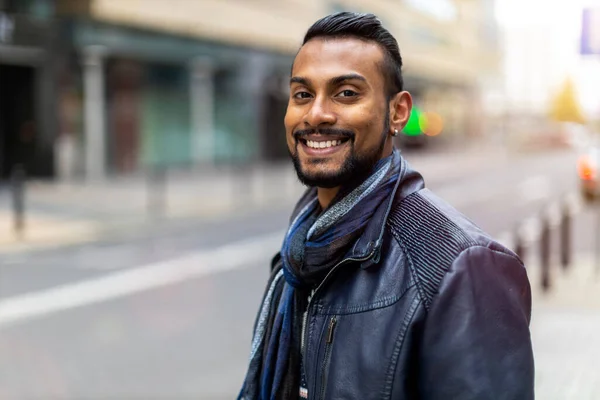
[273,160,534,400]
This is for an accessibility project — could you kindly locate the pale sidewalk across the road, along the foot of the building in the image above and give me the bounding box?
[0,142,524,254]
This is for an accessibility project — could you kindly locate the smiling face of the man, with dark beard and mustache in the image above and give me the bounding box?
[285,38,392,188]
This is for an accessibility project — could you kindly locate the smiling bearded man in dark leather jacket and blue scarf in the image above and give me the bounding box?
[240,13,534,400]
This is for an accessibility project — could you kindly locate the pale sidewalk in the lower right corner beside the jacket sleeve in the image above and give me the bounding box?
[529,255,600,400]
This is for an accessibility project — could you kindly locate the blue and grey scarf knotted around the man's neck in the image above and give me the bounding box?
[238,150,400,400]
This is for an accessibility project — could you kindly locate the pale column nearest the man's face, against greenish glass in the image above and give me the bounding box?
[190,58,215,164]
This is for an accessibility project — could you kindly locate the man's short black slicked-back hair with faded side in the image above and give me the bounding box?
[302,11,404,100]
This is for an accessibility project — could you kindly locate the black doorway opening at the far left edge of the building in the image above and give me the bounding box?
[0,64,38,179]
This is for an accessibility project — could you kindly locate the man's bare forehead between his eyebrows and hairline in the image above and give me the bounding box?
[292,38,383,78]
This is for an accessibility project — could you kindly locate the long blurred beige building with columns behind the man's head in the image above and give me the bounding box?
[0,0,500,178]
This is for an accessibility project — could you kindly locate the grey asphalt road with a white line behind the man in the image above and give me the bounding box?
[0,151,594,400]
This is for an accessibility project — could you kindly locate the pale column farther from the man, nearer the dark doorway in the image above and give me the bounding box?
[83,46,106,180]
